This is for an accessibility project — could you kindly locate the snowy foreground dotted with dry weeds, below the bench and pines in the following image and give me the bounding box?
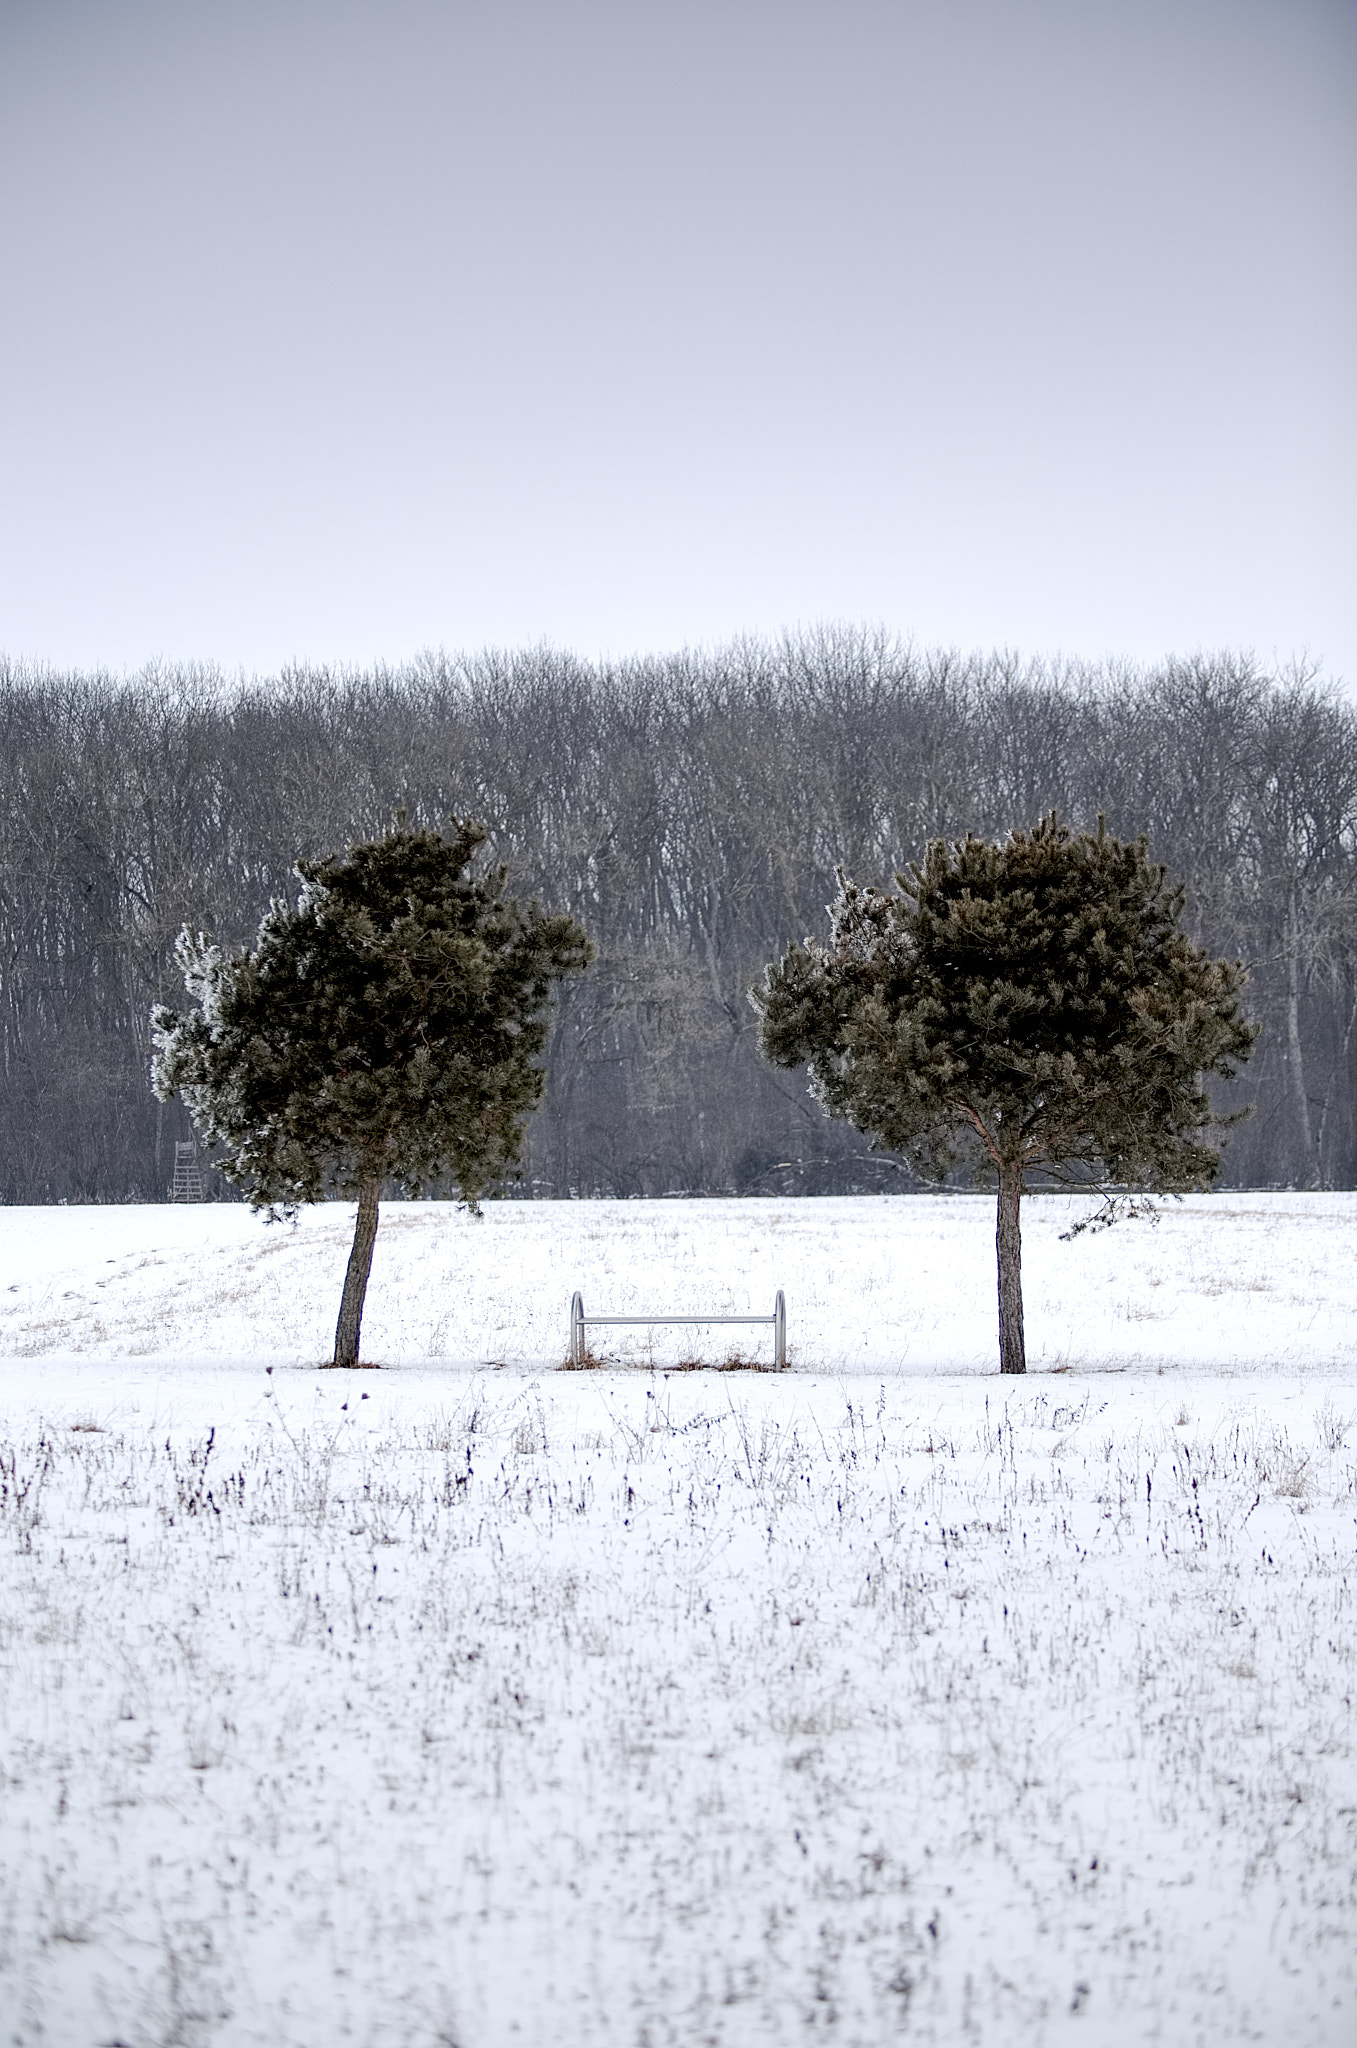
[0,1374,1357,2048]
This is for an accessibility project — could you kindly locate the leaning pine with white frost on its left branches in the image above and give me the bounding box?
[151,819,594,1366]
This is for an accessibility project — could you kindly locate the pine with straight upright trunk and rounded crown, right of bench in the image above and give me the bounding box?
[751,813,1255,1372]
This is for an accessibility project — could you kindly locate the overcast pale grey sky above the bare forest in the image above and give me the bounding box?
[0,0,1357,682]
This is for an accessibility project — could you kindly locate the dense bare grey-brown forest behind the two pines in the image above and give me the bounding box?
[0,631,1357,1202]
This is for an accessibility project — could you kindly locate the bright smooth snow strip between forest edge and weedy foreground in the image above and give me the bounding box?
[0,1194,1357,1401]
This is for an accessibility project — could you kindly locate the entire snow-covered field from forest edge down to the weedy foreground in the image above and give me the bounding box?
[0,1196,1357,2048]
